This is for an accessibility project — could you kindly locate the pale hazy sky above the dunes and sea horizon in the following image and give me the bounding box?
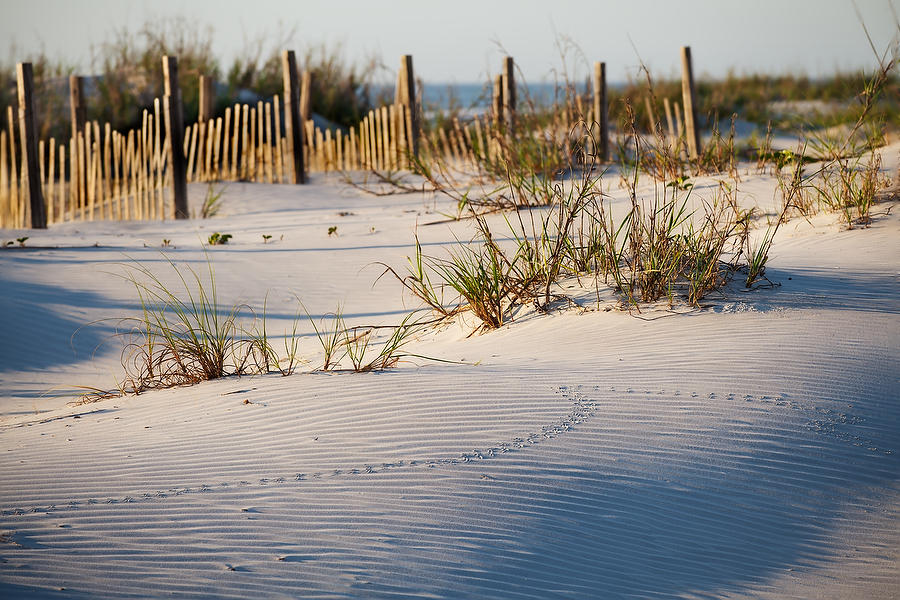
[0,0,900,82]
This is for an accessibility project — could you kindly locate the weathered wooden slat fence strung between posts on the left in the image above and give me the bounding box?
[0,95,411,228]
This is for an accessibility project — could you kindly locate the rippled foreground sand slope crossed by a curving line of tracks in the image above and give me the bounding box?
[0,373,900,598]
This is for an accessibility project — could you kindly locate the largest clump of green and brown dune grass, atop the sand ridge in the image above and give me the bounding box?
[386,146,771,329]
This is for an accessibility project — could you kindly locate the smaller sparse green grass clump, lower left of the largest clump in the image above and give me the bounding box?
[112,257,426,394]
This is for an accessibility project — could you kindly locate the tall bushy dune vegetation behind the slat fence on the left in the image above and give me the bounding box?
[0,20,380,139]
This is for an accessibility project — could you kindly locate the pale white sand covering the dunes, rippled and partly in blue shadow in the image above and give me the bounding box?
[0,146,900,598]
